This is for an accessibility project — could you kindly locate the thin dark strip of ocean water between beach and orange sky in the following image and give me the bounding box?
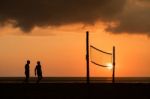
[0,77,150,83]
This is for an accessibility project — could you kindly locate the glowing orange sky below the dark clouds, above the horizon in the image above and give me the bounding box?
[0,23,150,77]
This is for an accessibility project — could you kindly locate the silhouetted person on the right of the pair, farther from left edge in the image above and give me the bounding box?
[35,61,43,83]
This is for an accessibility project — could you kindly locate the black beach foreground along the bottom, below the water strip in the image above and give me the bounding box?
[0,83,150,99]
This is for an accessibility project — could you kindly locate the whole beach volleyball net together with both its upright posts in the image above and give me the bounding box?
[86,31,115,84]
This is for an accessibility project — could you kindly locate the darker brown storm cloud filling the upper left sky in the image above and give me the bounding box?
[0,0,126,32]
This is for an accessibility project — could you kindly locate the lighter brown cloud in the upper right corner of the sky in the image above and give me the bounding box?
[106,0,150,35]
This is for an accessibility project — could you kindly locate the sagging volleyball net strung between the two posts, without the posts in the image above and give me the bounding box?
[90,45,112,67]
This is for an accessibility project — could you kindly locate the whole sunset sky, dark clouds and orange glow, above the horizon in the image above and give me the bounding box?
[0,0,150,77]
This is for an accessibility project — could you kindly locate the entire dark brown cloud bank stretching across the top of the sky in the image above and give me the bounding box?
[0,0,150,35]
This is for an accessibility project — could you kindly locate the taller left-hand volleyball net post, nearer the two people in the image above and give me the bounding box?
[86,31,90,84]
